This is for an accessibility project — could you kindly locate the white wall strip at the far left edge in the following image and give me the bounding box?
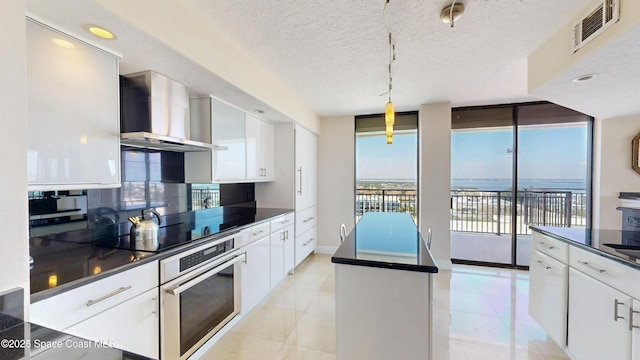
[0,1,29,310]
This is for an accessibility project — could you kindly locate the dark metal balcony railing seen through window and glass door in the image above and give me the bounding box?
[356,189,587,235]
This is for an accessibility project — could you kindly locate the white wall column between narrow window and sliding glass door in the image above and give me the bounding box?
[418,102,451,269]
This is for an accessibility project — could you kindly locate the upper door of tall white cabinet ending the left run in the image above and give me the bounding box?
[295,126,318,211]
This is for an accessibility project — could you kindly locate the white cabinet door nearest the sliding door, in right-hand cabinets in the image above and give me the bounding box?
[529,250,569,348]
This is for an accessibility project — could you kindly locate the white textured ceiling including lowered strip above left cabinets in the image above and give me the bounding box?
[27,0,592,121]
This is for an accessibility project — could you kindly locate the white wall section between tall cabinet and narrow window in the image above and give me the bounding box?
[317,116,355,254]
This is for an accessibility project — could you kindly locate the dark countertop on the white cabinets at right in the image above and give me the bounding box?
[530,226,640,269]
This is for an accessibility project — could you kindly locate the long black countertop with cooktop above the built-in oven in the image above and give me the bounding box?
[29,208,293,303]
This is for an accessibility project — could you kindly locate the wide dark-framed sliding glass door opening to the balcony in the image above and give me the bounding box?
[451,103,592,266]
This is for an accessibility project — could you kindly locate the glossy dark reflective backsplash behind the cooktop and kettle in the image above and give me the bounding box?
[29,148,255,242]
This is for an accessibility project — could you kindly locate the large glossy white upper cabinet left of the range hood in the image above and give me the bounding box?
[26,19,120,190]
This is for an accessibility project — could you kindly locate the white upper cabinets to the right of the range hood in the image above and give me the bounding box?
[185,96,274,183]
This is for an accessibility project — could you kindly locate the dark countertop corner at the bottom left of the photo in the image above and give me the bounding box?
[0,313,147,360]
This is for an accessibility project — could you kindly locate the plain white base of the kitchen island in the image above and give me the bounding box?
[335,264,433,360]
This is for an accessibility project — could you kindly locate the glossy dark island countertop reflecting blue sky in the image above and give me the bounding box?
[331,212,438,273]
